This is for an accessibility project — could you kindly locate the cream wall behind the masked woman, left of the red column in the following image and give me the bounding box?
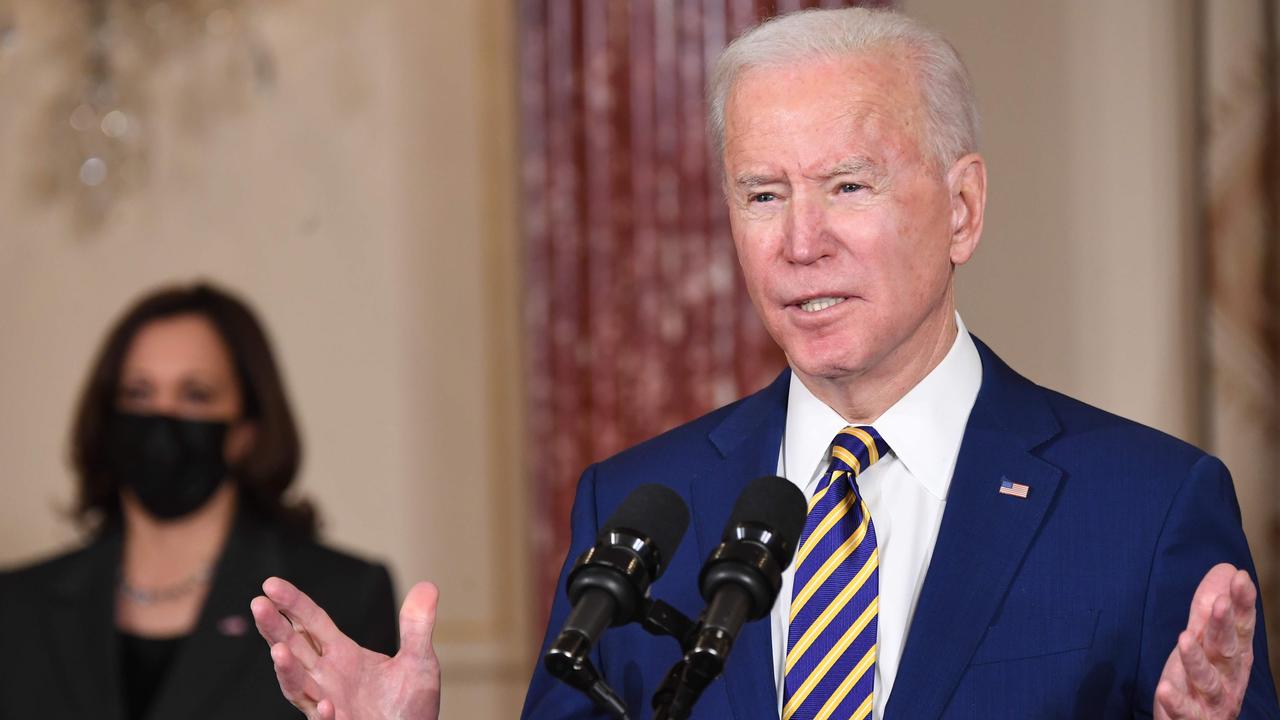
[0,0,536,717]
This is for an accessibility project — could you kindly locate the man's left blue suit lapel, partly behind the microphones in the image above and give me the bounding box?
[690,370,791,720]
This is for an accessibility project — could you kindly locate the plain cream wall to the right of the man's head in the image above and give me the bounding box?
[902,0,1254,561]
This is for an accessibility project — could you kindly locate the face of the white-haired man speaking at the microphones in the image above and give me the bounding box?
[724,51,972,380]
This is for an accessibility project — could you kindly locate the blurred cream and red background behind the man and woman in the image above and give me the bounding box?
[0,0,1280,717]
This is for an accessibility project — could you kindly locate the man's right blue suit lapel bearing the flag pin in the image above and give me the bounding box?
[884,338,1062,717]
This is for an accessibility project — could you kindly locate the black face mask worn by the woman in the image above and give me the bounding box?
[106,413,230,520]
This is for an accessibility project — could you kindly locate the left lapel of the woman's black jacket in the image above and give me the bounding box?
[42,530,124,720]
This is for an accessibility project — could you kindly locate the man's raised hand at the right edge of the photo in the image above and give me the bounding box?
[1156,562,1257,720]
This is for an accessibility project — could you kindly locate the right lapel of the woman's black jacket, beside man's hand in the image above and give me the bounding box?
[147,512,283,720]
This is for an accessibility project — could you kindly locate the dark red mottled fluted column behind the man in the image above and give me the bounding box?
[520,0,886,612]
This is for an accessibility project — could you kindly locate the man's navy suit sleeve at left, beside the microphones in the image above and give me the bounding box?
[521,465,609,720]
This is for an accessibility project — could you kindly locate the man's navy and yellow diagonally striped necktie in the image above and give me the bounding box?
[782,427,888,720]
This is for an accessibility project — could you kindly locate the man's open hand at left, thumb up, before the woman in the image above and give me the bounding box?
[250,578,440,720]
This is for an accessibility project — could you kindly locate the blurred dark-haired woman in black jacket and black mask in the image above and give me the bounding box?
[0,284,397,720]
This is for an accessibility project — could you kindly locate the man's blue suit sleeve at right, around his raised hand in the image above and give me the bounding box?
[1134,456,1280,719]
